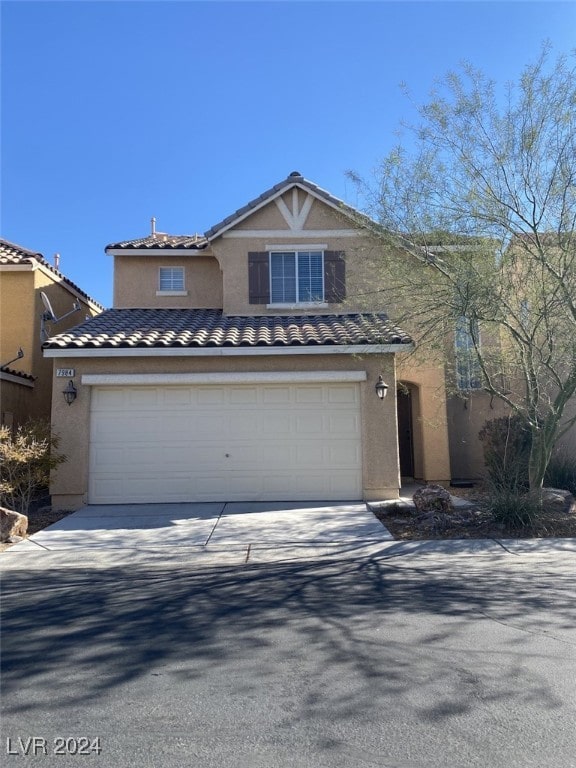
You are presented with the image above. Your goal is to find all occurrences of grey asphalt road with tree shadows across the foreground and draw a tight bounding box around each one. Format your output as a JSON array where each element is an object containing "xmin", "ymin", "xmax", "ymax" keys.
[{"xmin": 0, "ymin": 553, "xmax": 576, "ymax": 768}]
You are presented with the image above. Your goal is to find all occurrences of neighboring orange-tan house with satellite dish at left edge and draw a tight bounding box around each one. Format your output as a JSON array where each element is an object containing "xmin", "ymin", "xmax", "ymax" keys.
[{"xmin": 0, "ymin": 240, "xmax": 103, "ymax": 427}]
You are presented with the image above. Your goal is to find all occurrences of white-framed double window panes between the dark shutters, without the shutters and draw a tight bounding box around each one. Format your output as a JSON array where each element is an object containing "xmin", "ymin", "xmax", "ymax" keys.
[{"xmin": 270, "ymin": 251, "xmax": 324, "ymax": 304}]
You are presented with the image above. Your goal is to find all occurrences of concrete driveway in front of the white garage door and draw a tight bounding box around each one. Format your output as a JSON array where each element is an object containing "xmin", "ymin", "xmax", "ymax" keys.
[{"xmin": 2, "ymin": 502, "xmax": 392, "ymax": 566}]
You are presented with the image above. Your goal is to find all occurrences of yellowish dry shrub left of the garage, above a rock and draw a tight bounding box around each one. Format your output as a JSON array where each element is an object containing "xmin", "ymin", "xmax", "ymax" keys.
[{"xmin": 0, "ymin": 421, "xmax": 66, "ymax": 514}]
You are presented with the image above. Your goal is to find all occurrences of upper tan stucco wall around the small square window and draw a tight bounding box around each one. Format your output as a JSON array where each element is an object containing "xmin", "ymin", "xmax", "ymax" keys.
[{"xmin": 114, "ymin": 255, "xmax": 222, "ymax": 309}]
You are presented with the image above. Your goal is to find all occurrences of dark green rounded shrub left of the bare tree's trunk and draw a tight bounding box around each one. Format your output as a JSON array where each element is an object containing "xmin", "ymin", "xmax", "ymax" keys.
[{"xmin": 478, "ymin": 416, "xmax": 532, "ymax": 494}]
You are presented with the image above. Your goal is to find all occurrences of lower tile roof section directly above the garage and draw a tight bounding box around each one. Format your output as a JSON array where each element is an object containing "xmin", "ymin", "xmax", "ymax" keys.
[{"xmin": 43, "ymin": 309, "xmax": 412, "ymax": 350}]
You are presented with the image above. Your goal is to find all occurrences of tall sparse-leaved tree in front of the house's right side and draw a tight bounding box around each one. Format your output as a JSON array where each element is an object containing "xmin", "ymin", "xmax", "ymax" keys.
[{"xmin": 349, "ymin": 47, "xmax": 576, "ymax": 489}]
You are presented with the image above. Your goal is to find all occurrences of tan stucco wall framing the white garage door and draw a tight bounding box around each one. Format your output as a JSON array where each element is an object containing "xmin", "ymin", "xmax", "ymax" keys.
[{"xmin": 51, "ymin": 355, "xmax": 400, "ymax": 508}]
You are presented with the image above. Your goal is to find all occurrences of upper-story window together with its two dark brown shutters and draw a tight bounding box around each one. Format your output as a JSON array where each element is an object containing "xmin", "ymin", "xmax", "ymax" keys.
[{"xmin": 248, "ymin": 245, "xmax": 346, "ymax": 308}]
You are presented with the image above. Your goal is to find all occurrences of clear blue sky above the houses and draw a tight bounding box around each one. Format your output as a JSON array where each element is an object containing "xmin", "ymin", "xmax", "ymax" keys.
[{"xmin": 0, "ymin": 0, "xmax": 576, "ymax": 306}]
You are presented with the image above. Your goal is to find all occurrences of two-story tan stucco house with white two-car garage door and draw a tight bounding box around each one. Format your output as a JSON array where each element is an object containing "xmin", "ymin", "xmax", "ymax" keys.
[{"xmin": 44, "ymin": 172, "xmax": 450, "ymax": 509}]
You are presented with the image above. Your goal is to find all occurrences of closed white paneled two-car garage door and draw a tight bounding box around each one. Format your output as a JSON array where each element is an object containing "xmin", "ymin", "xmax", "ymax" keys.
[{"xmin": 89, "ymin": 383, "xmax": 362, "ymax": 504}]
